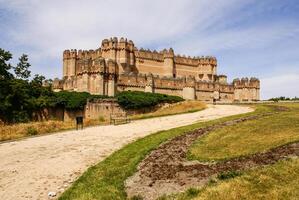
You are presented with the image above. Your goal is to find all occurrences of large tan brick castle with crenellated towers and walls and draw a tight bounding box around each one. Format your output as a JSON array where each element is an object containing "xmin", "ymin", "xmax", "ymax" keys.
[{"xmin": 53, "ymin": 38, "xmax": 260, "ymax": 103}]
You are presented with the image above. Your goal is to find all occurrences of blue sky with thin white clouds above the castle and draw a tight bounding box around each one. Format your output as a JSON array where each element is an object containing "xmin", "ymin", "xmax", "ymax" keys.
[{"xmin": 0, "ymin": 0, "xmax": 299, "ymax": 99}]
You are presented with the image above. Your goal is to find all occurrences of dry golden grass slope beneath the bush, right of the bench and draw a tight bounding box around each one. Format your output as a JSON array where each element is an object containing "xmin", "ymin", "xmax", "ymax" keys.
[{"xmin": 130, "ymin": 101, "xmax": 206, "ymax": 119}]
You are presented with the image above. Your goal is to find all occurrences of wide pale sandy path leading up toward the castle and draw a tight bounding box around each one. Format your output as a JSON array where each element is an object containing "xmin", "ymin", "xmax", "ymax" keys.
[{"xmin": 0, "ymin": 105, "xmax": 252, "ymax": 200}]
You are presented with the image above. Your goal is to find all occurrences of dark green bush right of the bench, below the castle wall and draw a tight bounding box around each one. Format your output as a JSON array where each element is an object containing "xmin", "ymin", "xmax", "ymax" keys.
[{"xmin": 116, "ymin": 91, "xmax": 184, "ymax": 110}]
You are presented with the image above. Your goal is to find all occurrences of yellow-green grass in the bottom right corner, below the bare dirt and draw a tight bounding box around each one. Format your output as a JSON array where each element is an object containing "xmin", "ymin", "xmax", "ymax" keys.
[{"xmin": 163, "ymin": 158, "xmax": 299, "ymax": 200}]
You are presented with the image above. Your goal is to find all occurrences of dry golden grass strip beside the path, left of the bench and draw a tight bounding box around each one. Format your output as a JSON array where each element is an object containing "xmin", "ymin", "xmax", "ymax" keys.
[{"xmin": 0, "ymin": 120, "xmax": 108, "ymax": 141}]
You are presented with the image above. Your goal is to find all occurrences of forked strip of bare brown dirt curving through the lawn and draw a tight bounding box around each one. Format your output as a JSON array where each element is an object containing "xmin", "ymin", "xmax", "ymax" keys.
[{"xmin": 126, "ymin": 113, "xmax": 299, "ymax": 200}]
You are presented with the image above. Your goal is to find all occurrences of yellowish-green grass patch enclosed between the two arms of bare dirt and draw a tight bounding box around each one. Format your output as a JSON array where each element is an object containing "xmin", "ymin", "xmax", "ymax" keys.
[{"xmin": 188, "ymin": 103, "xmax": 299, "ymax": 161}]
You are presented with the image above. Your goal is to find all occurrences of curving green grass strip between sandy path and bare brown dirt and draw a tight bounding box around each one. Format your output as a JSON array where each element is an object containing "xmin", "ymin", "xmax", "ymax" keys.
[{"xmin": 59, "ymin": 106, "xmax": 264, "ymax": 200}]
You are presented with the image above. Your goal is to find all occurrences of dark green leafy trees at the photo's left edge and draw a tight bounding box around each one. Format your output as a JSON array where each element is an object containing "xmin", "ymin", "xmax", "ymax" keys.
[{"xmin": 0, "ymin": 49, "xmax": 55, "ymax": 123}]
